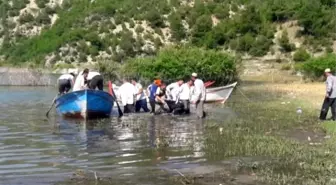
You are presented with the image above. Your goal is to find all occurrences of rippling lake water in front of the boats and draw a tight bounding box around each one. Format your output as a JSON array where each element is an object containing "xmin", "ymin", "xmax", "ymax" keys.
[{"xmin": 0, "ymin": 87, "xmax": 236, "ymax": 185}]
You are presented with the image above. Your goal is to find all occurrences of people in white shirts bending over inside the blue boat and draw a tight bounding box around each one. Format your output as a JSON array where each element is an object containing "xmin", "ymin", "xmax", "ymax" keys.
[{"xmin": 58, "ymin": 69, "xmax": 104, "ymax": 95}]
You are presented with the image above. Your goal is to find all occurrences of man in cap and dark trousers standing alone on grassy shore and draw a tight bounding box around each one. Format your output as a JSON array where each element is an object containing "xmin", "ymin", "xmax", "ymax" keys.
[{"xmin": 320, "ymin": 68, "xmax": 336, "ymax": 120}]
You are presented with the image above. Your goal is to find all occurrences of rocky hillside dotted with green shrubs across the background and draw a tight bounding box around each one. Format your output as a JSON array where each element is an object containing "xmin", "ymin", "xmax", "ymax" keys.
[{"xmin": 0, "ymin": 0, "xmax": 336, "ymax": 66}]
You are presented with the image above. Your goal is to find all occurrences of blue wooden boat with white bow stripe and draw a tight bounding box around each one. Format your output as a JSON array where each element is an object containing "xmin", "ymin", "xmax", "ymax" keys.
[{"xmin": 55, "ymin": 90, "xmax": 114, "ymax": 119}]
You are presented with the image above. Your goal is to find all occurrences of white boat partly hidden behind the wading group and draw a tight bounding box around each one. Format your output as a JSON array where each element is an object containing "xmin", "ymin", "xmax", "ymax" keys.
[{"xmin": 205, "ymin": 82, "xmax": 237, "ymax": 103}]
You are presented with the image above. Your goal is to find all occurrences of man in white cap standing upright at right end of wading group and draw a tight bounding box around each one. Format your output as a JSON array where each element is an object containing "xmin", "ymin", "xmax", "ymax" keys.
[{"xmin": 191, "ymin": 73, "xmax": 206, "ymax": 118}]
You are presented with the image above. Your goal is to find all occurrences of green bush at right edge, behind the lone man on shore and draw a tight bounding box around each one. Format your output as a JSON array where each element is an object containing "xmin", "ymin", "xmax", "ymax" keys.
[{"xmin": 300, "ymin": 54, "xmax": 336, "ymax": 78}]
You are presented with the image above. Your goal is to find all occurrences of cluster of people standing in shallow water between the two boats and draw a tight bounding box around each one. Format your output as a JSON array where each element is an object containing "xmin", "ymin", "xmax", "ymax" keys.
[{"xmin": 118, "ymin": 73, "xmax": 206, "ymax": 118}]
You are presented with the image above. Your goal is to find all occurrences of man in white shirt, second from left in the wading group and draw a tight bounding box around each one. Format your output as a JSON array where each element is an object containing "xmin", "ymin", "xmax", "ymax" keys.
[{"xmin": 131, "ymin": 78, "xmax": 149, "ymax": 112}]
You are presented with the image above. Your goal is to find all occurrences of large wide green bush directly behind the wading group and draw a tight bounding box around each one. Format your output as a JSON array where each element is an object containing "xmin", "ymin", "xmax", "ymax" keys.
[{"xmin": 123, "ymin": 47, "xmax": 237, "ymax": 85}]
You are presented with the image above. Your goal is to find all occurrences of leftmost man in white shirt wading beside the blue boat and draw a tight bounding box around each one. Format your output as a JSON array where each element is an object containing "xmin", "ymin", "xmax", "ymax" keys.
[{"xmin": 119, "ymin": 79, "xmax": 136, "ymax": 113}]
